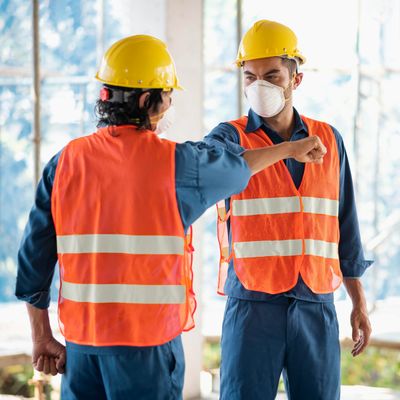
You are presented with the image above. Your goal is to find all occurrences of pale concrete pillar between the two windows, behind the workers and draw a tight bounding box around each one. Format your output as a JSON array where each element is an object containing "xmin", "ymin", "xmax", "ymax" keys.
[{"xmin": 107, "ymin": 0, "xmax": 203, "ymax": 399}]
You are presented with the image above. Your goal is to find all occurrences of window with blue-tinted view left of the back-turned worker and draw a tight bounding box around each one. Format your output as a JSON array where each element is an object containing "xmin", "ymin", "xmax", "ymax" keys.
[{"xmin": 0, "ymin": 0, "xmax": 165, "ymax": 302}]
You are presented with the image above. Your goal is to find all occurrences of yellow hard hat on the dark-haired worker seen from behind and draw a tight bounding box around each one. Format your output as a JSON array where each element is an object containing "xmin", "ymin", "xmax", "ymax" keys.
[{"xmin": 96, "ymin": 35, "xmax": 183, "ymax": 90}]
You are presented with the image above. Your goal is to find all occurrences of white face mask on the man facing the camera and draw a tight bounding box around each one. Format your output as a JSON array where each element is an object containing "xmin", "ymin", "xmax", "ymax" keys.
[{"xmin": 244, "ymin": 80, "xmax": 287, "ymax": 118}]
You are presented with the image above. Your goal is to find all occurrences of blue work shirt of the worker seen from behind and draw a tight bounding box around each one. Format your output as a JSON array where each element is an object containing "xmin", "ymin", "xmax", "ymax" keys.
[{"xmin": 15, "ymin": 134, "xmax": 251, "ymax": 354}]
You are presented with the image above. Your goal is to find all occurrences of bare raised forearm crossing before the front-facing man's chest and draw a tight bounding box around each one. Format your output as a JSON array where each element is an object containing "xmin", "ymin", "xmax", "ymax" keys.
[{"xmin": 242, "ymin": 142, "xmax": 292, "ymax": 175}]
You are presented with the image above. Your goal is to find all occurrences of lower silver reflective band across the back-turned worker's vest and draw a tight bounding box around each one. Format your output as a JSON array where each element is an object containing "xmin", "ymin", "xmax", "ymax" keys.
[{"xmin": 61, "ymin": 282, "xmax": 186, "ymax": 304}]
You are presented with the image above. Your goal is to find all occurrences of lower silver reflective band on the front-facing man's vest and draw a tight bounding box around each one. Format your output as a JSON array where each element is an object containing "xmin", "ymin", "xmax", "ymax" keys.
[{"xmin": 233, "ymin": 239, "xmax": 338, "ymax": 259}]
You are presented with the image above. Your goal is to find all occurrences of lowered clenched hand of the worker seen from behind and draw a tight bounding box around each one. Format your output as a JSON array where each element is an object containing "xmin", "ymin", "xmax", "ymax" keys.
[{"xmin": 32, "ymin": 336, "xmax": 66, "ymax": 375}]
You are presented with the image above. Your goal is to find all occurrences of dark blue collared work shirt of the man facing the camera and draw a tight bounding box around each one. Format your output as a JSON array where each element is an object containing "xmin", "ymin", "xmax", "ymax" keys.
[{"xmin": 204, "ymin": 109, "xmax": 372, "ymax": 302}]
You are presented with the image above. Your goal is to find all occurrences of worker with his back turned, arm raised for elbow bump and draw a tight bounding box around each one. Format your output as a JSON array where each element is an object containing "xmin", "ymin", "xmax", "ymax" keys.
[{"xmin": 16, "ymin": 35, "xmax": 326, "ymax": 400}]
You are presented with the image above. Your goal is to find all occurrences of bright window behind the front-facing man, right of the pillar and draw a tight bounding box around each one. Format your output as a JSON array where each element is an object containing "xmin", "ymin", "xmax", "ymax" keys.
[{"xmin": 203, "ymin": 0, "xmax": 400, "ymax": 335}]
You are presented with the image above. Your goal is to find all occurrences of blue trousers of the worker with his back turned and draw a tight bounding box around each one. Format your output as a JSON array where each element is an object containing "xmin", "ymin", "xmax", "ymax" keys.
[{"xmin": 61, "ymin": 336, "xmax": 185, "ymax": 400}]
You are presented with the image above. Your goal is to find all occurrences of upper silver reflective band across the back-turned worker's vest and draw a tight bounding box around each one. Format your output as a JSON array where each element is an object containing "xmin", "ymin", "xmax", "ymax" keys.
[{"xmin": 57, "ymin": 235, "xmax": 184, "ymax": 255}]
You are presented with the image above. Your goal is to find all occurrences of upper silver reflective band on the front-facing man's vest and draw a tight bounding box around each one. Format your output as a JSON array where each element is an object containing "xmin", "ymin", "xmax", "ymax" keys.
[{"xmin": 232, "ymin": 196, "xmax": 339, "ymax": 217}]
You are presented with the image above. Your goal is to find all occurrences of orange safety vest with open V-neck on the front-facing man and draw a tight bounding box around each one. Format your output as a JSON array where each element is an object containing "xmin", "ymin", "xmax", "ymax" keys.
[{"xmin": 217, "ymin": 116, "xmax": 343, "ymax": 294}]
